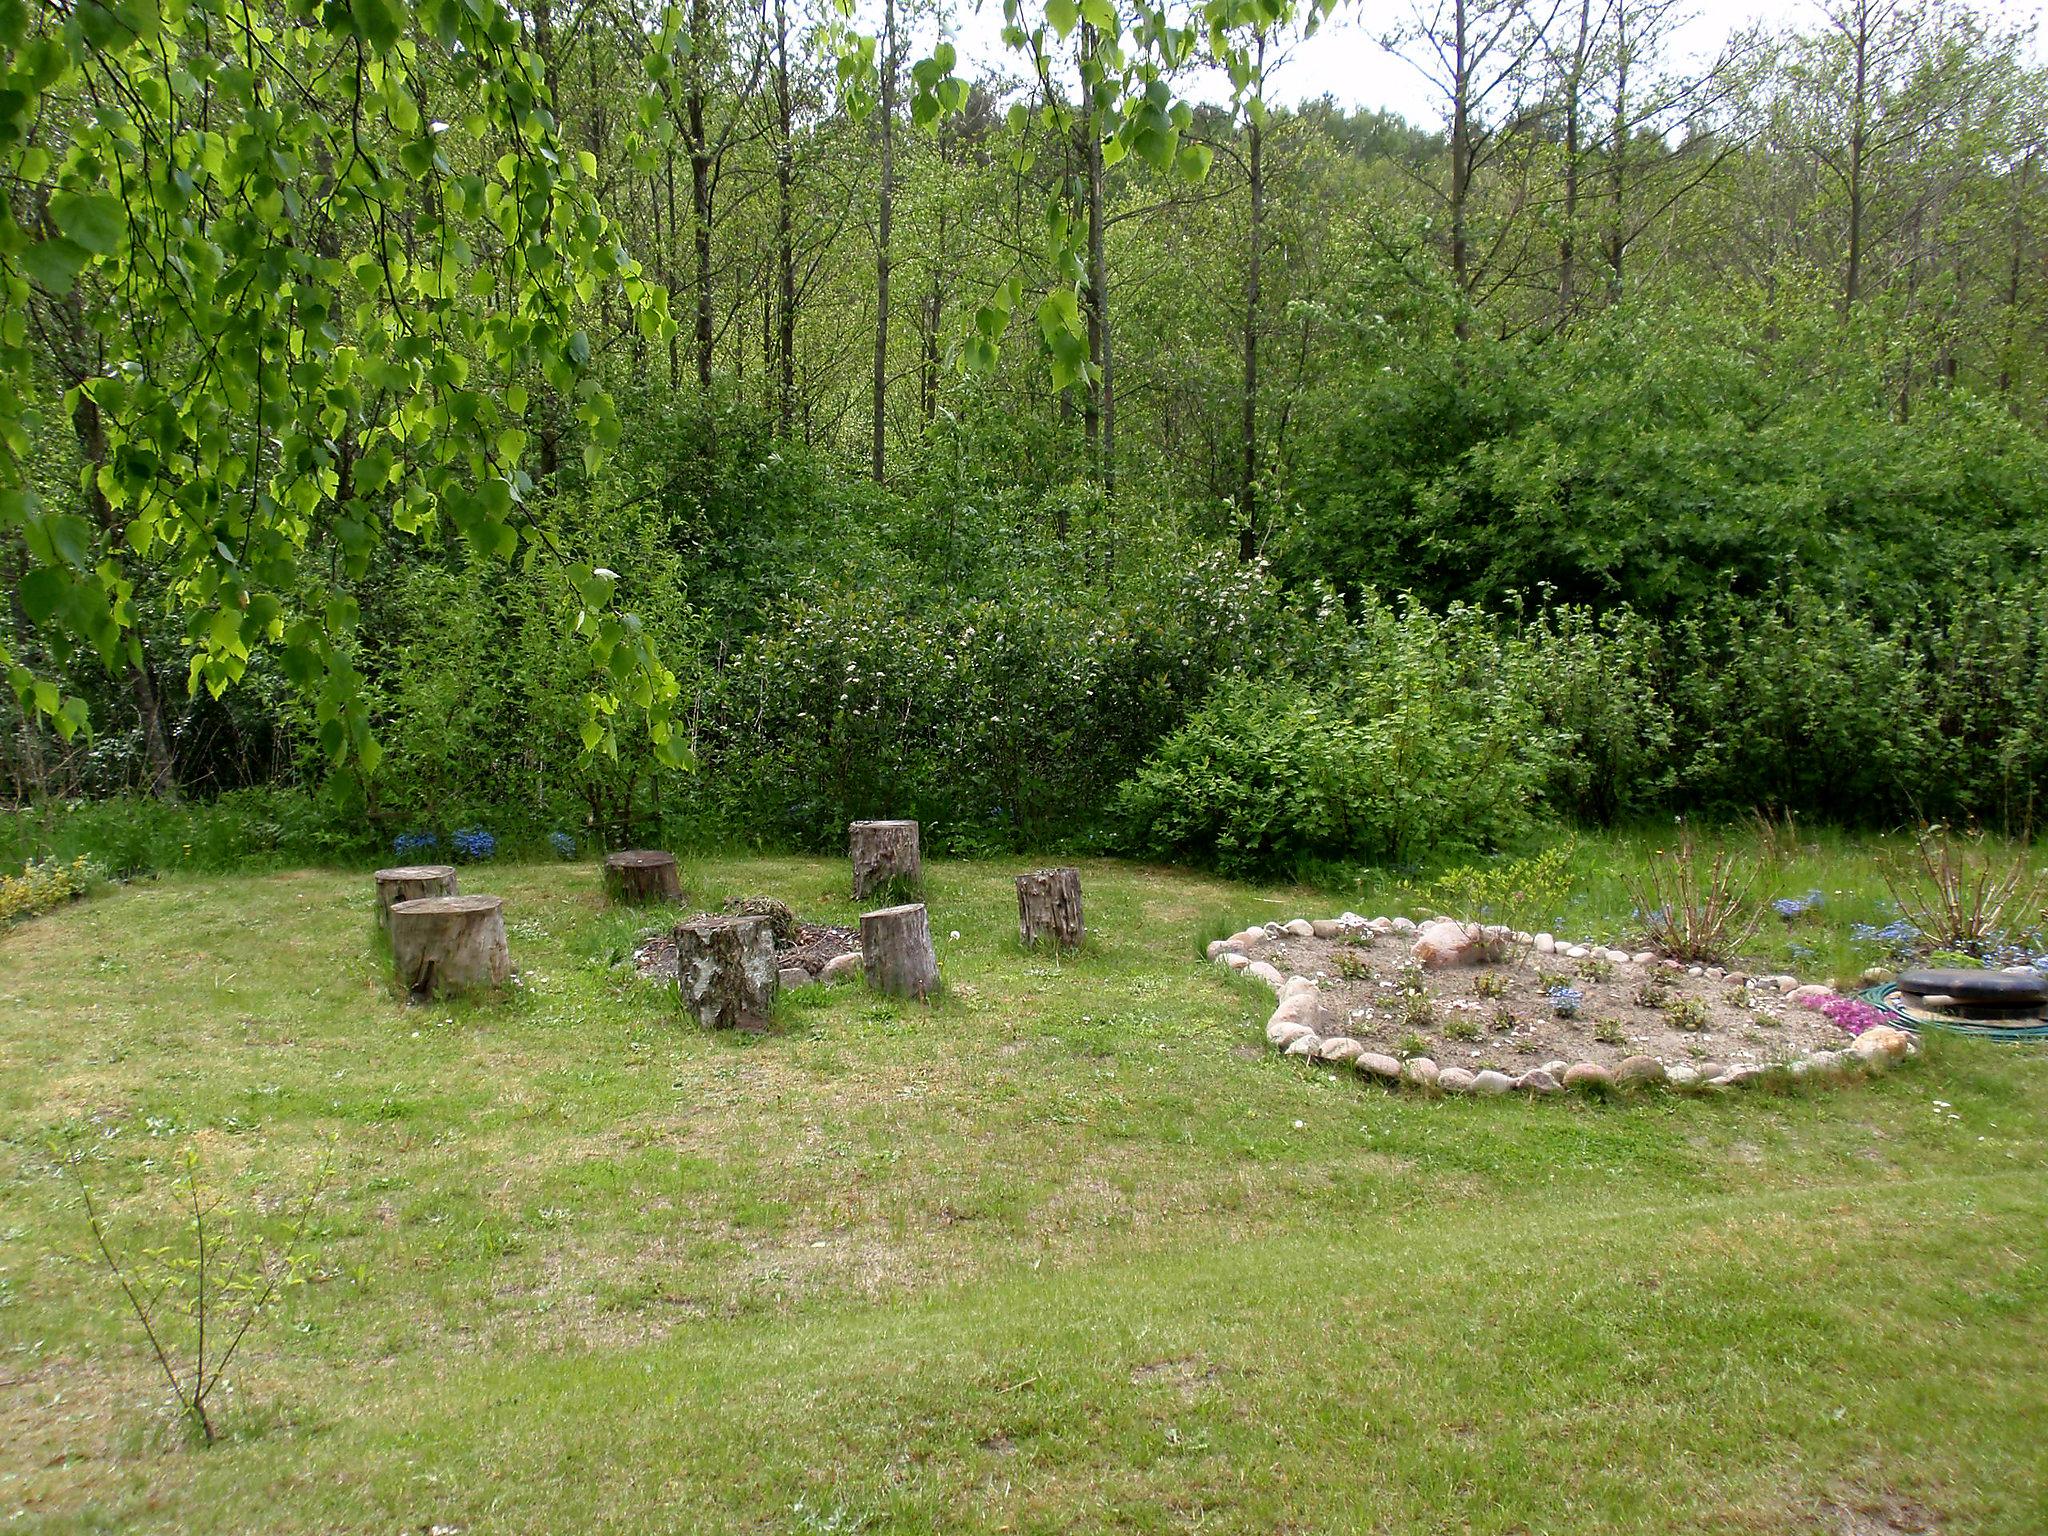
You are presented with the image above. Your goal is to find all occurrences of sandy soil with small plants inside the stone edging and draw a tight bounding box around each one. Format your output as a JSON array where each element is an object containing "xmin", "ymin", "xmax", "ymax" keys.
[{"xmin": 1245, "ymin": 934, "xmax": 1849, "ymax": 1073}]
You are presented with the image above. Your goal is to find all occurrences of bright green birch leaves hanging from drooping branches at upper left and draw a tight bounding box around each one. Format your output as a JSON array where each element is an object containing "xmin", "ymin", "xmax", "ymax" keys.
[{"xmin": 0, "ymin": 0, "xmax": 674, "ymax": 772}]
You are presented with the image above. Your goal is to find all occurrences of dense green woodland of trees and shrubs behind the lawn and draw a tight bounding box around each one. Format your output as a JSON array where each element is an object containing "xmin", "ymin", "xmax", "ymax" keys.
[{"xmin": 0, "ymin": 0, "xmax": 2048, "ymax": 874}]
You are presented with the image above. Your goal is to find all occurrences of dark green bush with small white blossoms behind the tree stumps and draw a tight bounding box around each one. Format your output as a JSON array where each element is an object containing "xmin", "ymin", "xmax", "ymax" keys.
[{"xmin": 688, "ymin": 557, "xmax": 1303, "ymax": 850}]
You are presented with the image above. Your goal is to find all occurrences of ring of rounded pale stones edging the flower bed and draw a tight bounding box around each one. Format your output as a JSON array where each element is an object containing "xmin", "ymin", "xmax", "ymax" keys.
[{"xmin": 1206, "ymin": 911, "xmax": 1919, "ymax": 1096}]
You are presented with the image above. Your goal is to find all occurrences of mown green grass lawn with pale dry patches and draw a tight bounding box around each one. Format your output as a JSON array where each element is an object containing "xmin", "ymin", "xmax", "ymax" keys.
[{"xmin": 0, "ymin": 850, "xmax": 2048, "ymax": 1536}]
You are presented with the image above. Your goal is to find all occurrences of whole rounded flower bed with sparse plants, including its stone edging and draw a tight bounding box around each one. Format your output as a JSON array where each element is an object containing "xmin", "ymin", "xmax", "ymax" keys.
[{"xmin": 1208, "ymin": 913, "xmax": 1919, "ymax": 1094}]
